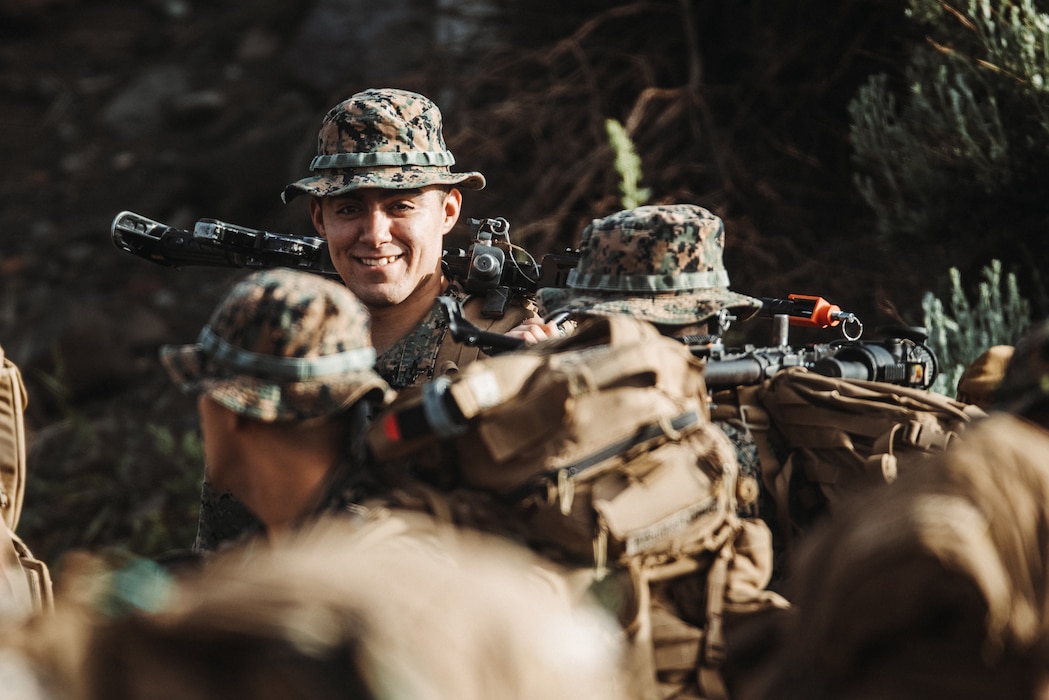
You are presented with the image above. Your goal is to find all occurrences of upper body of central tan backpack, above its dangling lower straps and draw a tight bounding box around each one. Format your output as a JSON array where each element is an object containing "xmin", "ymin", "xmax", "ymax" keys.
[{"xmin": 369, "ymin": 318, "xmax": 736, "ymax": 566}]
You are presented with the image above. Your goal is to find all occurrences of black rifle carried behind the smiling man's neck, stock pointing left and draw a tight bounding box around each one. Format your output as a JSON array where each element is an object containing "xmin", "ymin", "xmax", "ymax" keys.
[{"xmin": 111, "ymin": 211, "xmax": 578, "ymax": 318}]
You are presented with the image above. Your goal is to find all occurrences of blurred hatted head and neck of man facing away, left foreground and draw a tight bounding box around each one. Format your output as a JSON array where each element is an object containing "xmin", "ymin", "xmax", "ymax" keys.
[{"xmin": 160, "ymin": 265, "xmax": 390, "ymax": 538}]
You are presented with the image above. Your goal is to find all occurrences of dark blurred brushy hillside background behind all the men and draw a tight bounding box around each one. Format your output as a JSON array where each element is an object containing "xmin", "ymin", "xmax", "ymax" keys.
[{"xmin": 0, "ymin": 0, "xmax": 1049, "ymax": 560}]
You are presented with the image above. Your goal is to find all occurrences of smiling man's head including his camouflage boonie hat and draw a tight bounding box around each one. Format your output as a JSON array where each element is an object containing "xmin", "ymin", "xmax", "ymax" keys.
[{"xmin": 282, "ymin": 88, "xmax": 485, "ymax": 310}]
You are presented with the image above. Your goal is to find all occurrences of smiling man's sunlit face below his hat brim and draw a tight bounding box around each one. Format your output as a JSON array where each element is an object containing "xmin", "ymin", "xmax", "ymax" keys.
[{"xmin": 309, "ymin": 186, "xmax": 463, "ymax": 309}]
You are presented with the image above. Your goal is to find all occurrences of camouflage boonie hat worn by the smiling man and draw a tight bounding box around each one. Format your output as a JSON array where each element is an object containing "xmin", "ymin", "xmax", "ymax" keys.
[{"xmin": 281, "ymin": 88, "xmax": 485, "ymax": 201}]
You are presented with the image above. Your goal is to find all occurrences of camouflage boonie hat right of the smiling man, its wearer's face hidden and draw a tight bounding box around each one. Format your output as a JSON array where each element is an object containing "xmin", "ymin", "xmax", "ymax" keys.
[{"xmin": 537, "ymin": 205, "xmax": 762, "ymax": 325}]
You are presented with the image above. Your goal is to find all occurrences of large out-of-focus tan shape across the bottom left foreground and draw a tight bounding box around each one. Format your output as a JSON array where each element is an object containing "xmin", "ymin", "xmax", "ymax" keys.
[{"xmin": 0, "ymin": 513, "xmax": 626, "ymax": 700}]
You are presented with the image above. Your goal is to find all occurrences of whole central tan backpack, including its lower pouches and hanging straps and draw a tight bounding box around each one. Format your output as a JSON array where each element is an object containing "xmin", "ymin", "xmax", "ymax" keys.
[{"xmin": 369, "ymin": 317, "xmax": 786, "ymax": 698}]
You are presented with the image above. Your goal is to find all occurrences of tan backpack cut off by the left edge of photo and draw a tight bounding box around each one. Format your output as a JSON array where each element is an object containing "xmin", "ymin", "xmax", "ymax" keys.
[{"xmin": 0, "ymin": 347, "xmax": 52, "ymax": 614}]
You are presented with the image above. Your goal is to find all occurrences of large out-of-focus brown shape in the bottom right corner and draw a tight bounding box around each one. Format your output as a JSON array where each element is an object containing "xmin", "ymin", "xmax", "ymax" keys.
[{"xmin": 748, "ymin": 411, "xmax": 1049, "ymax": 700}]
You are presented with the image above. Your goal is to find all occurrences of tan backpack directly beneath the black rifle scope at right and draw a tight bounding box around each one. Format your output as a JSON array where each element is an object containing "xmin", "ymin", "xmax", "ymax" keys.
[{"xmin": 738, "ymin": 367, "xmax": 986, "ymax": 548}]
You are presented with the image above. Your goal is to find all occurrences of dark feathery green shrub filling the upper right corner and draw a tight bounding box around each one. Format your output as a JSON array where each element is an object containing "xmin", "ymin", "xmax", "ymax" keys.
[{"xmin": 849, "ymin": 0, "xmax": 1049, "ymax": 249}]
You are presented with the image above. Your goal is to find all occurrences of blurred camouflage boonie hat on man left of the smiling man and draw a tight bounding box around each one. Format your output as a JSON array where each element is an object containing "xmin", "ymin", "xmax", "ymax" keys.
[{"xmin": 160, "ymin": 269, "xmax": 389, "ymax": 422}]
